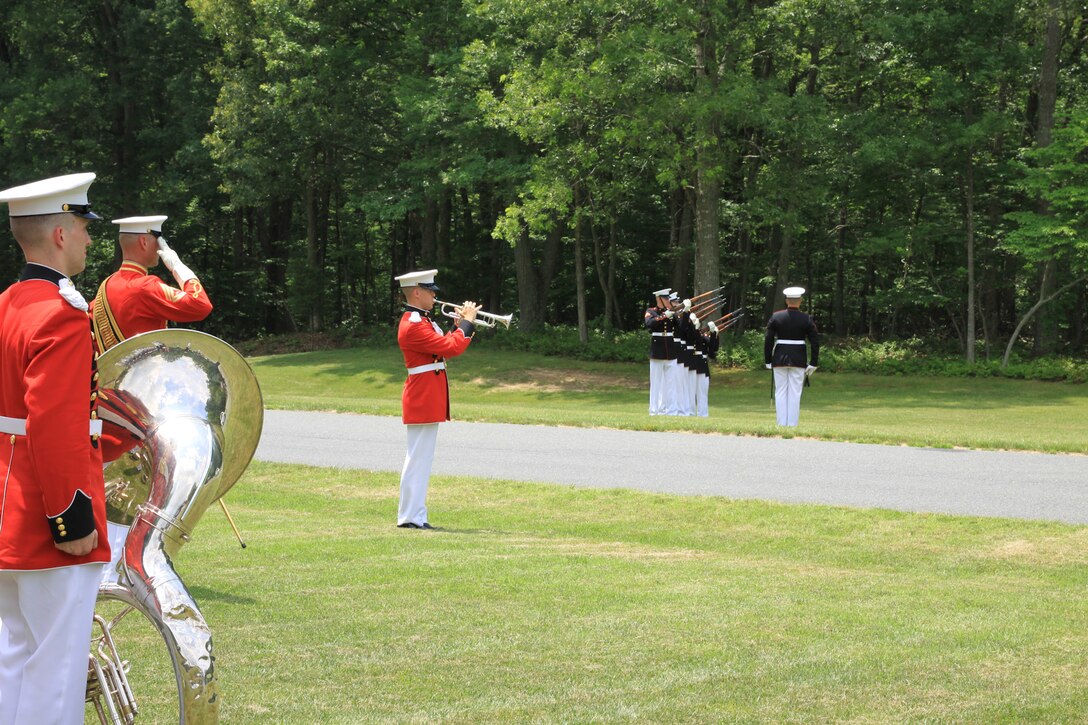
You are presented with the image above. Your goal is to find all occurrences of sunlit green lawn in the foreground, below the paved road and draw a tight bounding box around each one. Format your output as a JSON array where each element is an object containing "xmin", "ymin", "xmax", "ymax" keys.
[{"xmin": 91, "ymin": 463, "xmax": 1088, "ymax": 724}]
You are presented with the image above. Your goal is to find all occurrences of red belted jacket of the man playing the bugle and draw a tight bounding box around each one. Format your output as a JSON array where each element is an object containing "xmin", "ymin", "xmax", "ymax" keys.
[{"xmin": 397, "ymin": 307, "xmax": 473, "ymax": 426}]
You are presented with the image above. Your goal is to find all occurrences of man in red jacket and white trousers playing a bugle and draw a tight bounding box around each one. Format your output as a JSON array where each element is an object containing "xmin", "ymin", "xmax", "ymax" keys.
[{"xmin": 394, "ymin": 269, "xmax": 479, "ymax": 529}]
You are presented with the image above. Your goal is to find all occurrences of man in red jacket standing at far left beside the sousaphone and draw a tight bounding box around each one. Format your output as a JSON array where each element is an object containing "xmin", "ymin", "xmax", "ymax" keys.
[{"xmin": 0, "ymin": 173, "xmax": 110, "ymax": 724}]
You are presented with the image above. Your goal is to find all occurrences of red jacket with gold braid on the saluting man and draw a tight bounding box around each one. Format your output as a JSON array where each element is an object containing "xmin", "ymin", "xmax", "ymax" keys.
[{"xmin": 90, "ymin": 261, "xmax": 211, "ymax": 354}]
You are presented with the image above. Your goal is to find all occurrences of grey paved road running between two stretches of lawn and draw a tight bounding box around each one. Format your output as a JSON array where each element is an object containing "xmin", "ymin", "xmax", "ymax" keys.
[{"xmin": 256, "ymin": 410, "xmax": 1088, "ymax": 524}]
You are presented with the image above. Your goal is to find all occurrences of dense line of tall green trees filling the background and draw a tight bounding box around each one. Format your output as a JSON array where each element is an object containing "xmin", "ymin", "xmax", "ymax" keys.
[{"xmin": 0, "ymin": 0, "xmax": 1088, "ymax": 361}]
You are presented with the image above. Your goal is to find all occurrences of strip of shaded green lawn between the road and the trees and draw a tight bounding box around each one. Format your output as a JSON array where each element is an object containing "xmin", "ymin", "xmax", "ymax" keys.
[{"xmin": 251, "ymin": 341, "xmax": 1088, "ymax": 453}]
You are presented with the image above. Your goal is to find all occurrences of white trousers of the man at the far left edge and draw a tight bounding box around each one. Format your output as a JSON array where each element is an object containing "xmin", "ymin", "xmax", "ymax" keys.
[{"xmin": 0, "ymin": 564, "xmax": 102, "ymax": 725}]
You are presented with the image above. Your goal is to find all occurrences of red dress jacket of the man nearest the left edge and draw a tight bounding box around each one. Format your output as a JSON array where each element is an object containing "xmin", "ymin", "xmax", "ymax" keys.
[{"xmin": 0, "ymin": 265, "xmax": 110, "ymax": 570}]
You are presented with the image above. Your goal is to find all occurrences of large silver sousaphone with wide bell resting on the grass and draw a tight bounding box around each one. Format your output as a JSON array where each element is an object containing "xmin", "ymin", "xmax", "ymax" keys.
[{"xmin": 87, "ymin": 330, "xmax": 264, "ymax": 725}]
